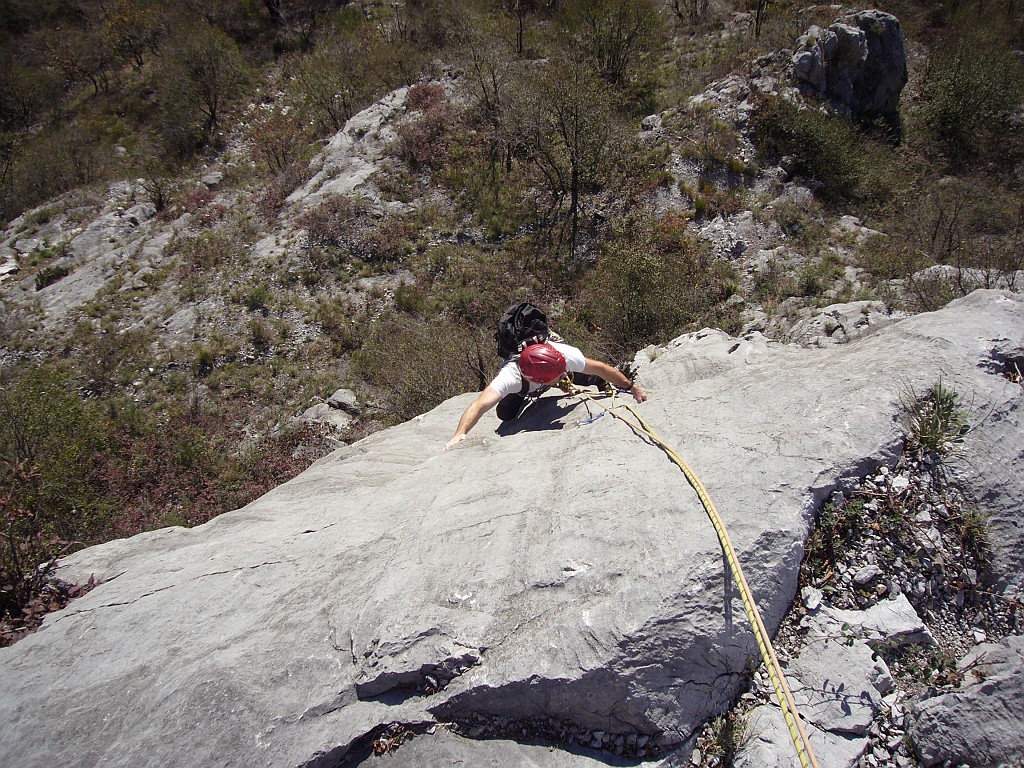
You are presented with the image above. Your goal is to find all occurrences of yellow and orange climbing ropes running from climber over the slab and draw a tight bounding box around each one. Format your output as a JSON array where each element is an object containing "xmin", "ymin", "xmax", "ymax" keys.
[{"xmin": 559, "ymin": 377, "xmax": 818, "ymax": 768}]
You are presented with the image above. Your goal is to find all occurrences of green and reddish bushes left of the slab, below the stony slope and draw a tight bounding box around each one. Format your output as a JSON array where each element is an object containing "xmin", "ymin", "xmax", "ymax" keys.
[{"xmin": 0, "ymin": 366, "xmax": 331, "ymax": 644}]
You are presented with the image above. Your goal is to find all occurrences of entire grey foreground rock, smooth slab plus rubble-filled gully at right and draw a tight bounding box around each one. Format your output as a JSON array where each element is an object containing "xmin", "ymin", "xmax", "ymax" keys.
[{"xmin": 0, "ymin": 292, "xmax": 1024, "ymax": 766}]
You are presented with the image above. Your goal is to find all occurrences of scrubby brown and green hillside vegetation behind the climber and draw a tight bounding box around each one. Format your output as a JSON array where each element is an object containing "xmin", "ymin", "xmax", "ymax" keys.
[{"xmin": 0, "ymin": 0, "xmax": 1024, "ymax": 638}]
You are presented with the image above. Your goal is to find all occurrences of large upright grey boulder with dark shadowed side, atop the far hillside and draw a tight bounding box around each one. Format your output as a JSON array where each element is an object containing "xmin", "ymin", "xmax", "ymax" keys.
[{"xmin": 793, "ymin": 10, "xmax": 907, "ymax": 119}]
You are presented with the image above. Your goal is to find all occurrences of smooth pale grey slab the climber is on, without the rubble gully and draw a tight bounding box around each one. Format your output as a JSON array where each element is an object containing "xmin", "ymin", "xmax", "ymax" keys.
[{"xmin": 0, "ymin": 291, "xmax": 1024, "ymax": 766}]
